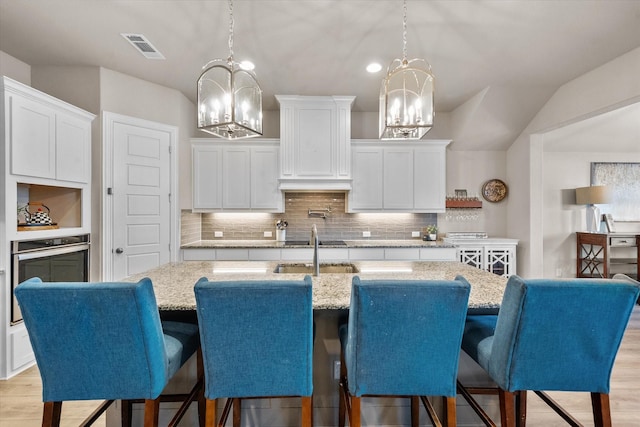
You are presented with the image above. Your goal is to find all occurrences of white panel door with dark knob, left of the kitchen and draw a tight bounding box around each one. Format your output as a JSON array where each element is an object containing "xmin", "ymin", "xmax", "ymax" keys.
[{"xmin": 112, "ymin": 122, "xmax": 171, "ymax": 280}]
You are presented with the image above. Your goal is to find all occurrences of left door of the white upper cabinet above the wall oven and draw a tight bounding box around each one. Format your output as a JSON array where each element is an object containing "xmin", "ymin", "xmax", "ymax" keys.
[{"xmin": 9, "ymin": 95, "xmax": 56, "ymax": 179}]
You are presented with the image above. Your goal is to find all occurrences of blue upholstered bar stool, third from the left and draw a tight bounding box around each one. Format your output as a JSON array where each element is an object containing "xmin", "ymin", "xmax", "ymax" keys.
[{"xmin": 338, "ymin": 276, "xmax": 471, "ymax": 427}]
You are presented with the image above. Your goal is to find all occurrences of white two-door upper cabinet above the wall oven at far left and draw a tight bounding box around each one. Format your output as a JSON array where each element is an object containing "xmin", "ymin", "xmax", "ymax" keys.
[{"xmin": 3, "ymin": 77, "xmax": 95, "ymax": 183}]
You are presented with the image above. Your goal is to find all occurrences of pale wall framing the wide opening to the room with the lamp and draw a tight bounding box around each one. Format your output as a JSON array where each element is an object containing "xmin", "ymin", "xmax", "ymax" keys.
[{"xmin": 507, "ymin": 48, "xmax": 640, "ymax": 277}]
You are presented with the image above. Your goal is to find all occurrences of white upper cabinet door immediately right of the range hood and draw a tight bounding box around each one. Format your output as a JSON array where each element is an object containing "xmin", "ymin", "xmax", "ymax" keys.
[{"xmin": 349, "ymin": 147, "xmax": 383, "ymax": 211}]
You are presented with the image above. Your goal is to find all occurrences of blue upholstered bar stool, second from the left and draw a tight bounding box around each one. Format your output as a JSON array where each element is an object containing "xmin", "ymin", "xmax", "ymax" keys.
[{"xmin": 195, "ymin": 276, "xmax": 313, "ymax": 427}]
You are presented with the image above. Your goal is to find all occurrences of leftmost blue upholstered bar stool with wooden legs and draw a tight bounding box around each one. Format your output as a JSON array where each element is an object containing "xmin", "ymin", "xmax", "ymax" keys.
[{"xmin": 15, "ymin": 278, "xmax": 204, "ymax": 426}]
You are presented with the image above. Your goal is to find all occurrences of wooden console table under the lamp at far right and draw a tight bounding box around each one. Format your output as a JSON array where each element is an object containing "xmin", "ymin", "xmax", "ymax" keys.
[{"xmin": 576, "ymin": 233, "xmax": 640, "ymax": 279}]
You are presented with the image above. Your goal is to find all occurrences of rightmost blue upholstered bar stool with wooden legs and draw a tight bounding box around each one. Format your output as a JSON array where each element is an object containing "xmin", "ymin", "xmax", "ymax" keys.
[{"xmin": 460, "ymin": 276, "xmax": 640, "ymax": 426}]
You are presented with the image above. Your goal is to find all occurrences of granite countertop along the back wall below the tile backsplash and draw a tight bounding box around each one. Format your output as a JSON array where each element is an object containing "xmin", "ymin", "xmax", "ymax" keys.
[{"xmin": 180, "ymin": 239, "xmax": 454, "ymax": 249}]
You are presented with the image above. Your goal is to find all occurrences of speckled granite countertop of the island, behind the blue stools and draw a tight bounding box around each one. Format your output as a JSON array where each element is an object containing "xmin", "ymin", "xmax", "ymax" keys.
[{"xmin": 125, "ymin": 261, "xmax": 507, "ymax": 310}]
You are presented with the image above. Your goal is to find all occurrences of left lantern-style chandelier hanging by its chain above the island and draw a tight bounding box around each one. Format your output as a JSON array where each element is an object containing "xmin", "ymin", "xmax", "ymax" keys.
[{"xmin": 198, "ymin": 0, "xmax": 262, "ymax": 139}]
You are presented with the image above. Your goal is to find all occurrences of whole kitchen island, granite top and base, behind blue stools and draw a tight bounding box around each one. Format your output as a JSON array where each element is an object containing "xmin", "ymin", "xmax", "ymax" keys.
[{"xmin": 116, "ymin": 261, "xmax": 507, "ymax": 427}]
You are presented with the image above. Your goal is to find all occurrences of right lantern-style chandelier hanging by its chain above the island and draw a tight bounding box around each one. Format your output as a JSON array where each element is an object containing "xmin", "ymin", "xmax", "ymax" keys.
[{"xmin": 380, "ymin": 0, "xmax": 435, "ymax": 140}]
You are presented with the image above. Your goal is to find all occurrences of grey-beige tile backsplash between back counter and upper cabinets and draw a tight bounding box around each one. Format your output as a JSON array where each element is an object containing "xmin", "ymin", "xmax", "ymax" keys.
[{"xmin": 181, "ymin": 192, "xmax": 437, "ymax": 244}]
